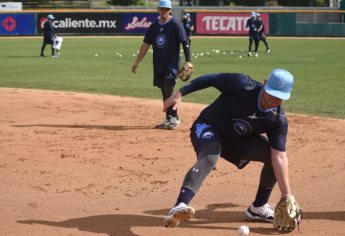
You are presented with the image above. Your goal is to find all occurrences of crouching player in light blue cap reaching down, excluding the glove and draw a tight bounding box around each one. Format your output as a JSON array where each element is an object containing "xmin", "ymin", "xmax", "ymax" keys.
[{"xmin": 164, "ymin": 69, "xmax": 297, "ymax": 227}]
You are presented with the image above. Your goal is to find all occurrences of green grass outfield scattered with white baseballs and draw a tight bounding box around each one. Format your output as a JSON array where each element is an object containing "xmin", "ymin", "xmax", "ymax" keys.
[{"xmin": 0, "ymin": 37, "xmax": 345, "ymax": 119}]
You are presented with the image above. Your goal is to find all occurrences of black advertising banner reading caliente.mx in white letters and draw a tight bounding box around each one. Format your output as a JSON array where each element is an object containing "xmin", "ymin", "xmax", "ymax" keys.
[{"xmin": 37, "ymin": 13, "xmax": 121, "ymax": 34}]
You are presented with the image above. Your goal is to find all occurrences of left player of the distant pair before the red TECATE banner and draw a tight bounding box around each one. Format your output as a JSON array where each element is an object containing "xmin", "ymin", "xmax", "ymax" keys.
[{"xmin": 246, "ymin": 12, "xmax": 261, "ymax": 57}]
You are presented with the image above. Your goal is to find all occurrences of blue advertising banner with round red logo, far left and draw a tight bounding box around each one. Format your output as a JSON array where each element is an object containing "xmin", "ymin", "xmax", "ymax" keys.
[{"xmin": 0, "ymin": 14, "xmax": 35, "ymax": 35}]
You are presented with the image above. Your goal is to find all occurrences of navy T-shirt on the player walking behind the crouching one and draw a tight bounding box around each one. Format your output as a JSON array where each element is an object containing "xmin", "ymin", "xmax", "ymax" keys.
[{"xmin": 144, "ymin": 17, "xmax": 188, "ymax": 74}]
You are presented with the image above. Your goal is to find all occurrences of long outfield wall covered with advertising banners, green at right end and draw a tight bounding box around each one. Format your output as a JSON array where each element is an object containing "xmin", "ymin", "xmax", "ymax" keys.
[{"xmin": 0, "ymin": 9, "xmax": 345, "ymax": 37}]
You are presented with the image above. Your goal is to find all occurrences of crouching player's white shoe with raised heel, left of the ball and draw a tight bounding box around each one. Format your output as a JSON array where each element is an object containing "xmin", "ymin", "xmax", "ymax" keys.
[{"xmin": 164, "ymin": 202, "xmax": 195, "ymax": 227}]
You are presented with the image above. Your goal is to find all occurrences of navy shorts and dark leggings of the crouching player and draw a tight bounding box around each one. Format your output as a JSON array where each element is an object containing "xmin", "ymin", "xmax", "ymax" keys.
[{"xmin": 182, "ymin": 122, "xmax": 277, "ymax": 193}]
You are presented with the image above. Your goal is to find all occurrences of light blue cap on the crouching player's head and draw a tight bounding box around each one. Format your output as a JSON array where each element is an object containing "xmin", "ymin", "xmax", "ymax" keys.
[{"xmin": 265, "ymin": 69, "xmax": 293, "ymax": 100}]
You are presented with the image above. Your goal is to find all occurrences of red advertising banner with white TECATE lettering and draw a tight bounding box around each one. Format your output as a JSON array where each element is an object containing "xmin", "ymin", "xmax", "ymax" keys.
[{"xmin": 196, "ymin": 12, "xmax": 269, "ymax": 35}]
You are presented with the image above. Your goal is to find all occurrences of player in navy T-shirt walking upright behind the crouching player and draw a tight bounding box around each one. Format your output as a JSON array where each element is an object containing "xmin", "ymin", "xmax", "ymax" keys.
[{"xmin": 132, "ymin": 0, "xmax": 190, "ymax": 129}]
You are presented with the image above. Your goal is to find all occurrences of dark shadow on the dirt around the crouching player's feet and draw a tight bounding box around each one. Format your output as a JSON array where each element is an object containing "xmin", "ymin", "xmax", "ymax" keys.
[{"xmin": 17, "ymin": 203, "xmax": 345, "ymax": 236}]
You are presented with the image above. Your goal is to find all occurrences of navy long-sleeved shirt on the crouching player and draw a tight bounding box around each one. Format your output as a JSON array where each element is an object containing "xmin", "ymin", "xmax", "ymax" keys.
[{"xmin": 180, "ymin": 73, "xmax": 288, "ymax": 151}]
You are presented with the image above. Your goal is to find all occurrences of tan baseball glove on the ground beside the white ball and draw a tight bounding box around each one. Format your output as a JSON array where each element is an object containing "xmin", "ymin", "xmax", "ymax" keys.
[{"xmin": 273, "ymin": 195, "xmax": 302, "ymax": 232}]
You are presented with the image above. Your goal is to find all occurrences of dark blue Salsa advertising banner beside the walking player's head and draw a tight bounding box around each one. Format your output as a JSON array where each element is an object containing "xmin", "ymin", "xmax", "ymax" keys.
[{"xmin": 121, "ymin": 13, "xmax": 158, "ymax": 34}]
